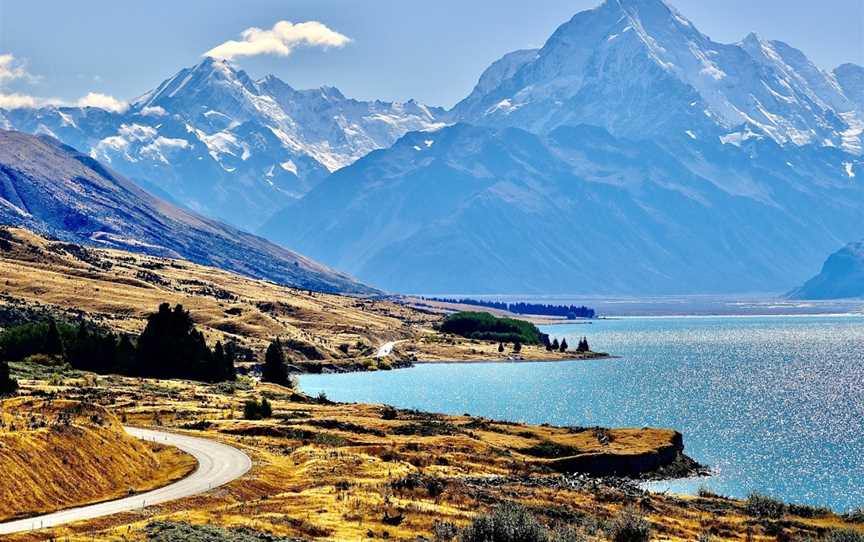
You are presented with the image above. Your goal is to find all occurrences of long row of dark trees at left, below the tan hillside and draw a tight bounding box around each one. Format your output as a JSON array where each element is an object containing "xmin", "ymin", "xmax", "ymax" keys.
[{"xmin": 0, "ymin": 303, "xmax": 237, "ymax": 382}]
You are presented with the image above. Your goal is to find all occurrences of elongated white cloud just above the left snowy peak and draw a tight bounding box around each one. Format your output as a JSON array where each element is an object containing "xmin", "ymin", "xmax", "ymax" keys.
[{"xmin": 204, "ymin": 21, "xmax": 351, "ymax": 60}]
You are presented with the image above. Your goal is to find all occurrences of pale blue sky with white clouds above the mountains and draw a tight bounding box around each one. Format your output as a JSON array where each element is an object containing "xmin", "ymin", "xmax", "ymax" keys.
[{"xmin": 0, "ymin": 0, "xmax": 864, "ymax": 107}]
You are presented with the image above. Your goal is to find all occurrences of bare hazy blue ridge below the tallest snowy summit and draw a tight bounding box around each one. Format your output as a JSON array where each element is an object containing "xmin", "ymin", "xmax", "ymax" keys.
[{"xmin": 263, "ymin": 124, "xmax": 864, "ymax": 294}]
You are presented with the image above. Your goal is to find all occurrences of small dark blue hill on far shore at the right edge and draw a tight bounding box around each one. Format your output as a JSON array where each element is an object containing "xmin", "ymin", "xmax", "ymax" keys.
[{"xmin": 789, "ymin": 242, "xmax": 864, "ymax": 299}]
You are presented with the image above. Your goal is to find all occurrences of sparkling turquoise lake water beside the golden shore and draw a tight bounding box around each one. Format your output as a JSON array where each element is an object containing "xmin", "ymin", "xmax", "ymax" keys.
[{"xmin": 300, "ymin": 316, "xmax": 864, "ymax": 510}]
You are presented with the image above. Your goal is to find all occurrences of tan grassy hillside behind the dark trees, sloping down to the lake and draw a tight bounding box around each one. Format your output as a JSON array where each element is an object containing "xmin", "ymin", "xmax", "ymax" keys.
[{"xmin": 0, "ymin": 228, "xmax": 588, "ymax": 370}]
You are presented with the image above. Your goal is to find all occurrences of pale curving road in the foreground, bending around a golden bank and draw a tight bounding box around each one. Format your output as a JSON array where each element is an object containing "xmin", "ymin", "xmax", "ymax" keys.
[{"xmin": 0, "ymin": 427, "xmax": 252, "ymax": 535}]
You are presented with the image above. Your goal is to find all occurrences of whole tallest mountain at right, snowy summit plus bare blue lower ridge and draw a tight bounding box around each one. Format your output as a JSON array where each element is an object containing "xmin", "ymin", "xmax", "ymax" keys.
[{"xmin": 261, "ymin": 0, "xmax": 864, "ymax": 294}]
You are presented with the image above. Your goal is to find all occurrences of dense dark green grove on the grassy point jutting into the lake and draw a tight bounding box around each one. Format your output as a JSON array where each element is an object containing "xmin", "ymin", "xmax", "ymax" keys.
[{"xmin": 441, "ymin": 312, "xmax": 548, "ymax": 348}]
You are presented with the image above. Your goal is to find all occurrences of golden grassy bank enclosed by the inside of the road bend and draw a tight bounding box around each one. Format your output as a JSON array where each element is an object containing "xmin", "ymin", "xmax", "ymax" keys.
[{"xmin": 0, "ymin": 398, "xmax": 196, "ymax": 521}]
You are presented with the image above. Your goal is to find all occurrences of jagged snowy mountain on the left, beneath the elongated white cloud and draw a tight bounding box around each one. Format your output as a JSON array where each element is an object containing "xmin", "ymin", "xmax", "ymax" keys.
[{"xmin": 0, "ymin": 58, "xmax": 443, "ymax": 229}]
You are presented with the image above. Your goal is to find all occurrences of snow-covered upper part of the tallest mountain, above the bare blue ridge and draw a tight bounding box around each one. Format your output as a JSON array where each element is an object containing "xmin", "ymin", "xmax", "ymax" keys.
[{"xmin": 452, "ymin": 0, "xmax": 864, "ymax": 153}]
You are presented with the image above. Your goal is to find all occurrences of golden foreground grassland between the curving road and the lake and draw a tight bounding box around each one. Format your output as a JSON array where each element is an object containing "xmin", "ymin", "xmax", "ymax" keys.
[{"xmin": 0, "ymin": 377, "xmax": 854, "ymax": 542}]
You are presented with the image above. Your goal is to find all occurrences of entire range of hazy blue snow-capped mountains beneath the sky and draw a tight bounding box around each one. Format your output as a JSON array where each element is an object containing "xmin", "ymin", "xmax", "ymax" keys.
[{"xmin": 0, "ymin": 0, "xmax": 864, "ymax": 294}]
